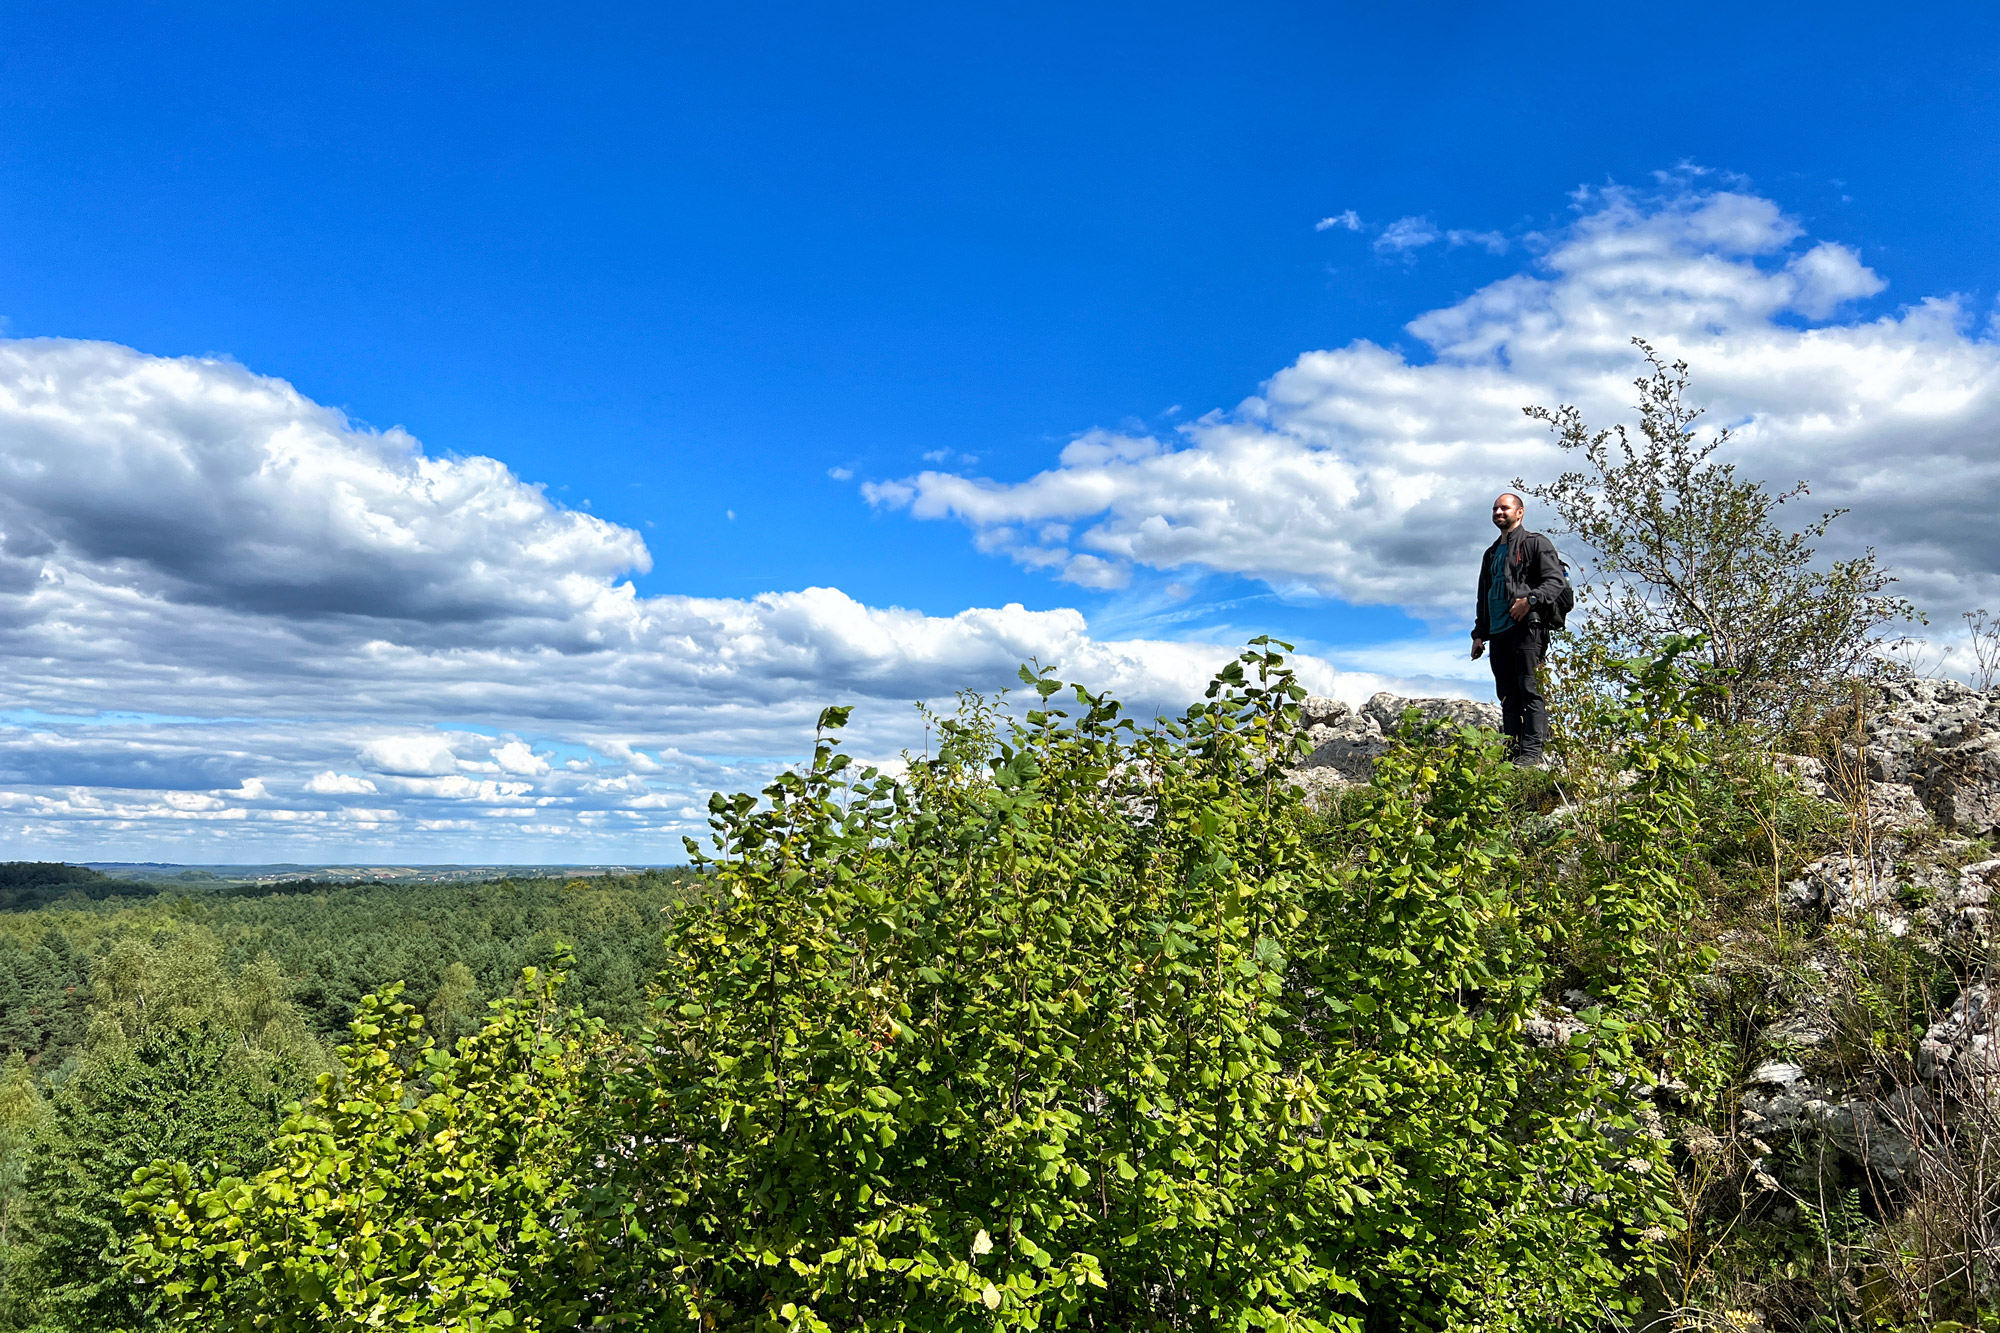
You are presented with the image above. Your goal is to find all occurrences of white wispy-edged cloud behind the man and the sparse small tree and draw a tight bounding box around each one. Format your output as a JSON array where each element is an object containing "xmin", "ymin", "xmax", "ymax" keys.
[{"xmin": 866, "ymin": 179, "xmax": 2000, "ymax": 618}]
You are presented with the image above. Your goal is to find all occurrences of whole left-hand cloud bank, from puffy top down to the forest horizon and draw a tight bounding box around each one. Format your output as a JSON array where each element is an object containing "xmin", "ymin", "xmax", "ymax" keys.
[{"xmin": 0, "ymin": 340, "xmax": 1408, "ymax": 861}]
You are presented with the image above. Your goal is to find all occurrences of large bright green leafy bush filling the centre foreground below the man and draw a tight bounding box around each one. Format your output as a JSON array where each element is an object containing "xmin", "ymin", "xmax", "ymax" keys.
[{"xmin": 488, "ymin": 644, "xmax": 1684, "ymax": 1329}]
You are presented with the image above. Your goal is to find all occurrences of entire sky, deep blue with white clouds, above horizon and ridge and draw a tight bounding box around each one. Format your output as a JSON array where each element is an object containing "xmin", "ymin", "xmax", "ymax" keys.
[{"xmin": 0, "ymin": 4, "xmax": 2000, "ymax": 861}]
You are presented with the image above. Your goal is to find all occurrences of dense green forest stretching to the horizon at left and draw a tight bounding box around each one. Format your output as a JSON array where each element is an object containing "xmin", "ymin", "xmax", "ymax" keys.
[{"xmin": 0, "ymin": 863, "xmax": 694, "ymax": 1329}]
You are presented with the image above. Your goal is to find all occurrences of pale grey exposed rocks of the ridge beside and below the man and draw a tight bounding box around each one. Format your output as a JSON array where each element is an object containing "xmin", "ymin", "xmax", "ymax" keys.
[{"xmin": 1292, "ymin": 681, "xmax": 2000, "ymax": 1189}]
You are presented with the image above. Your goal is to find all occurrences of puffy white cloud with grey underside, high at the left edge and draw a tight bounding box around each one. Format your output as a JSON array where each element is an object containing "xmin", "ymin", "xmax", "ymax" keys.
[{"xmin": 0, "ymin": 338, "xmax": 650, "ymax": 632}]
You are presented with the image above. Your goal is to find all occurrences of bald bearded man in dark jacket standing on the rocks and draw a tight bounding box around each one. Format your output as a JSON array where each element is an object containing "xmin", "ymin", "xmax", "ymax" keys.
[{"xmin": 1472, "ymin": 490, "xmax": 1566, "ymax": 769}]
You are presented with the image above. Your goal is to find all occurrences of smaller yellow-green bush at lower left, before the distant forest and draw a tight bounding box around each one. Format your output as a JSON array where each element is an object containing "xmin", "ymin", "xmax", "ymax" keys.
[{"xmin": 130, "ymin": 969, "xmax": 604, "ymax": 1333}]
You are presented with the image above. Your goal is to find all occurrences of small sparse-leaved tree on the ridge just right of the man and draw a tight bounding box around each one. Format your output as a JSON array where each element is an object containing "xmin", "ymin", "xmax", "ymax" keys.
[{"xmin": 1514, "ymin": 338, "xmax": 1920, "ymax": 727}]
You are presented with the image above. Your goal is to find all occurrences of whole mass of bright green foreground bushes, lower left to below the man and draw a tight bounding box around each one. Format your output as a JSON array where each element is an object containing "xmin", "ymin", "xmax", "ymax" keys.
[{"xmin": 117, "ymin": 640, "xmax": 1700, "ymax": 1333}]
